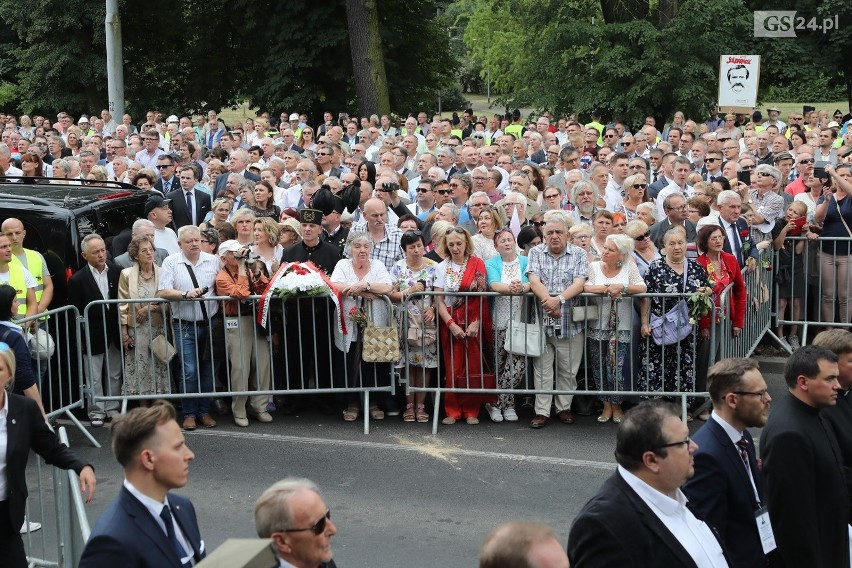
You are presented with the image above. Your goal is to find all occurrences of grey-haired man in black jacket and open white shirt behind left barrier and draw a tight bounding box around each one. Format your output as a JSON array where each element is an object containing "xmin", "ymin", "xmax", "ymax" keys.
[{"xmin": 68, "ymin": 233, "xmax": 124, "ymax": 428}]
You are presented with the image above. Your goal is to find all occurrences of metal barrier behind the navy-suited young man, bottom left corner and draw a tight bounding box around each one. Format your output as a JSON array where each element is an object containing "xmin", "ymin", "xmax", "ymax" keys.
[{"xmin": 23, "ymin": 428, "xmax": 91, "ymax": 568}]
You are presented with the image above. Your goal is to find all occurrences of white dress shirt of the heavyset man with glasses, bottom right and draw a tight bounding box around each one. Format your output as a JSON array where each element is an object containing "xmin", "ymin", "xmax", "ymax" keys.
[{"xmin": 618, "ymin": 466, "xmax": 728, "ymax": 568}]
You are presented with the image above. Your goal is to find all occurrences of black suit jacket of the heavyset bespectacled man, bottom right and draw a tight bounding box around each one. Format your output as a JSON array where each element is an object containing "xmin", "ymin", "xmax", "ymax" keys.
[{"xmin": 568, "ymin": 472, "xmax": 724, "ymax": 568}]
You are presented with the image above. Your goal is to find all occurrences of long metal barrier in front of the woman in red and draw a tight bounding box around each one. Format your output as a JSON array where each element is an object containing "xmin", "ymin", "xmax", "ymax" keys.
[{"xmin": 401, "ymin": 292, "xmax": 716, "ymax": 433}]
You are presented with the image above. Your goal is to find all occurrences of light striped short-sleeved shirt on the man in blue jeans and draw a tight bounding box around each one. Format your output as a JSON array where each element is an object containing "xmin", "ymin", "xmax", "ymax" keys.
[{"xmin": 159, "ymin": 252, "xmax": 220, "ymax": 321}]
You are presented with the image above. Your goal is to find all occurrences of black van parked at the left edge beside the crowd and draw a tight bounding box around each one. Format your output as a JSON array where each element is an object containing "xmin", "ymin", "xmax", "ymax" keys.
[{"xmin": 0, "ymin": 177, "xmax": 151, "ymax": 308}]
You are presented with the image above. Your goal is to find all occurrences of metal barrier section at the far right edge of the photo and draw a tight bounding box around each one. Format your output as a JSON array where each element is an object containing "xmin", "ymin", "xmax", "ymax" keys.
[{"xmin": 772, "ymin": 235, "xmax": 852, "ymax": 351}]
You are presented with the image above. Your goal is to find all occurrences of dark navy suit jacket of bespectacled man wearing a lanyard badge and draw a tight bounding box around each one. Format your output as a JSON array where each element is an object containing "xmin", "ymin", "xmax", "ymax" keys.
[{"xmin": 683, "ymin": 418, "xmax": 766, "ymax": 568}]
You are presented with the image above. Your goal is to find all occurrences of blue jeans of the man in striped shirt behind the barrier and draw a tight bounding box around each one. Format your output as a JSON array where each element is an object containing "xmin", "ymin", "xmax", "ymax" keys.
[{"xmin": 173, "ymin": 320, "xmax": 214, "ymax": 417}]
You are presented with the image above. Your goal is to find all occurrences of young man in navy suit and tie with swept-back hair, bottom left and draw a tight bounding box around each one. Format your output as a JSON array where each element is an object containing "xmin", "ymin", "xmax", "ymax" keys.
[{"xmin": 80, "ymin": 400, "xmax": 206, "ymax": 568}]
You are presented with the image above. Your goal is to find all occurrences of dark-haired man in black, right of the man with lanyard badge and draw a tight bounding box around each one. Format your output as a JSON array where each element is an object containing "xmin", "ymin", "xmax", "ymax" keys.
[{"xmin": 760, "ymin": 345, "xmax": 849, "ymax": 568}]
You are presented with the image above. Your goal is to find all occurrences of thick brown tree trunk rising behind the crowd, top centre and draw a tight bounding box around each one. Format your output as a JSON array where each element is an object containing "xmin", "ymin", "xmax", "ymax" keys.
[{"xmin": 346, "ymin": 0, "xmax": 390, "ymax": 116}]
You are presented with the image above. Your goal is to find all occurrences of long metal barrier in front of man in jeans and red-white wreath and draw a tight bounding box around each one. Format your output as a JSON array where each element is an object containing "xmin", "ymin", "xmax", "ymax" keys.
[{"xmin": 83, "ymin": 296, "xmax": 394, "ymax": 434}]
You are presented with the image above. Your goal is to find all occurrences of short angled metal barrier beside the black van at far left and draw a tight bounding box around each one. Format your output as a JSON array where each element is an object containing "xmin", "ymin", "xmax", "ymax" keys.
[{"xmin": 16, "ymin": 306, "xmax": 101, "ymax": 448}]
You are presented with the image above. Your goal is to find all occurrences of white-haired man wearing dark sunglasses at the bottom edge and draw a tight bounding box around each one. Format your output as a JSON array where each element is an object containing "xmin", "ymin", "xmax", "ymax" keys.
[{"xmin": 254, "ymin": 477, "xmax": 337, "ymax": 568}]
